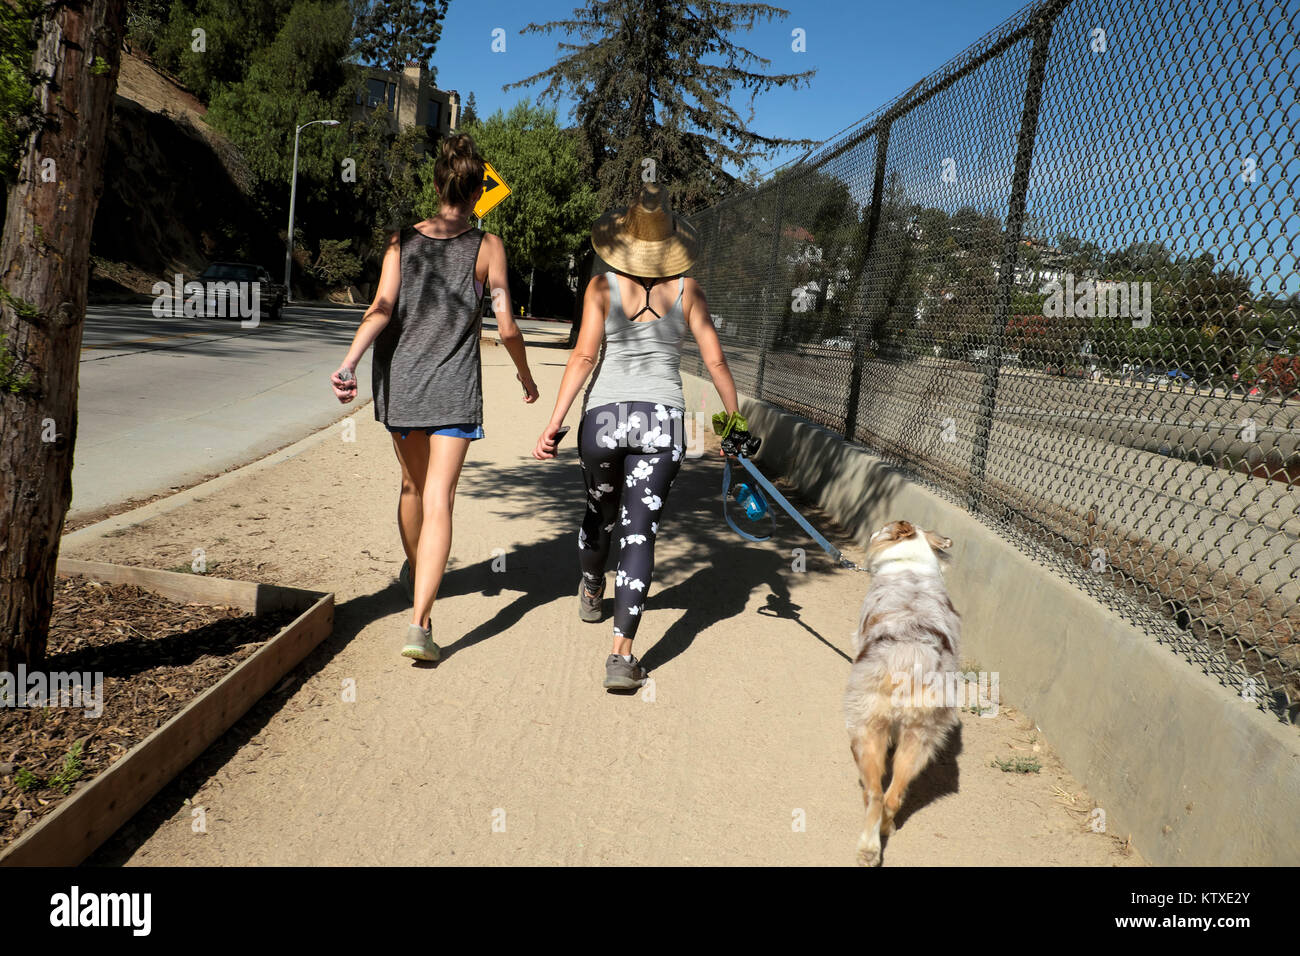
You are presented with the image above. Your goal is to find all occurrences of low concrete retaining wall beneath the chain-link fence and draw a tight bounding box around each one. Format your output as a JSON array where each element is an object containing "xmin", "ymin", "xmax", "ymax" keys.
[{"xmin": 683, "ymin": 375, "xmax": 1300, "ymax": 866}]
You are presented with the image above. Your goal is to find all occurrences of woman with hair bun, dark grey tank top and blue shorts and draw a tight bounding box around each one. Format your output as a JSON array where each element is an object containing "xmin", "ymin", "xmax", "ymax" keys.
[{"xmin": 332, "ymin": 134, "xmax": 537, "ymax": 661}]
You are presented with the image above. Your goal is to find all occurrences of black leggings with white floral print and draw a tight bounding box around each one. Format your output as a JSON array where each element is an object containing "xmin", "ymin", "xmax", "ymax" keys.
[{"xmin": 577, "ymin": 402, "xmax": 685, "ymax": 640}]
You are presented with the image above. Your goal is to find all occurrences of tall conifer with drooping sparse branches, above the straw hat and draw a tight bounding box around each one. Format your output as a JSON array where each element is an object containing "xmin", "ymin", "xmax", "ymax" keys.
[{"xmin": 503, "ymin": 0, "xmax": 815, "ymax": 212}]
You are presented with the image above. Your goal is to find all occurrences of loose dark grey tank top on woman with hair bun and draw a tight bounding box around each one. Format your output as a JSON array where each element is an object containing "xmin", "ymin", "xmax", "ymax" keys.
[{"xmin": 371, "ymin": 226, "xmax": 486, "ymax": 428}]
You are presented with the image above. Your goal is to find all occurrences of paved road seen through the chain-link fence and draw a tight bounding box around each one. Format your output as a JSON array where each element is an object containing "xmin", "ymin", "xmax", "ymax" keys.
[{"xmin": 754, "ymin": 349, "xmax": 1300, "ymax": 630}]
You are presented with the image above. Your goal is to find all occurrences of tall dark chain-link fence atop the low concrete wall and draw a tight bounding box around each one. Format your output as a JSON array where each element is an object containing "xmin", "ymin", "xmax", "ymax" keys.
[{"xmin": 684, "ymin": 0, "xmax": 1300, "ymax": 722}]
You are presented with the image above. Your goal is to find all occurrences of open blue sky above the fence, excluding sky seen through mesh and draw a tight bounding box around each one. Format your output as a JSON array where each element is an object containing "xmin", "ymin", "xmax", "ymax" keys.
[{"xmin": 434, "ymin": 0, "xmax": 1027, "ymax": 169}]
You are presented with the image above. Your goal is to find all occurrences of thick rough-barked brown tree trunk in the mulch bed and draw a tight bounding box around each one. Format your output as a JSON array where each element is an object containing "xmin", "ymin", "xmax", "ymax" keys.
[{"xmin": 0, "ymin": 0, "xmax": 126, "ymax": 672}]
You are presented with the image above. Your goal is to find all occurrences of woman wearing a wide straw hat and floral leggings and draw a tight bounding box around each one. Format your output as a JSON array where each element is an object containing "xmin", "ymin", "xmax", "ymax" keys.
[{"xmin": 533, "ymin": 183, "xmax": 754, "ymax": 691}]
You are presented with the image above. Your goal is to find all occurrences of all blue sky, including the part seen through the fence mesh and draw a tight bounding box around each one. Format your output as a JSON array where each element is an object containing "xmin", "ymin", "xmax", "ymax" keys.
[{"xmin": 423, "ymin": 0, "xmax": 1300, "ymax": 294}]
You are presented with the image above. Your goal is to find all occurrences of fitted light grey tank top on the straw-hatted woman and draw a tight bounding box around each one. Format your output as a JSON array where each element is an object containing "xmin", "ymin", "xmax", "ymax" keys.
[{"xmin": 582, "ymin": 272, "xmax": 686, "ymax": 414}]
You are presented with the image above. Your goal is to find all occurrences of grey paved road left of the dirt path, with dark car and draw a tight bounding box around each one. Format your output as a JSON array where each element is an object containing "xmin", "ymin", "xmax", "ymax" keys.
[{"xmin": 69, "ymin": 303, "xmax": 568, "ymax": 519}]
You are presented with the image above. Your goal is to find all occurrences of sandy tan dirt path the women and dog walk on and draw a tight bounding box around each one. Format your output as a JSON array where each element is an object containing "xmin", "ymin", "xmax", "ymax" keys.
[{"xmin": 65, "ymin": 349, "xmax": 1141, "ymax": 866}]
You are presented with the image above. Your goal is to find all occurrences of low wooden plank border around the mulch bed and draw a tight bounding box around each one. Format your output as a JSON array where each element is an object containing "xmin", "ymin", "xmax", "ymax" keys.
[{"xmin": 0, "ymin": 558, "xmax": 334, "ymax": 866}]
